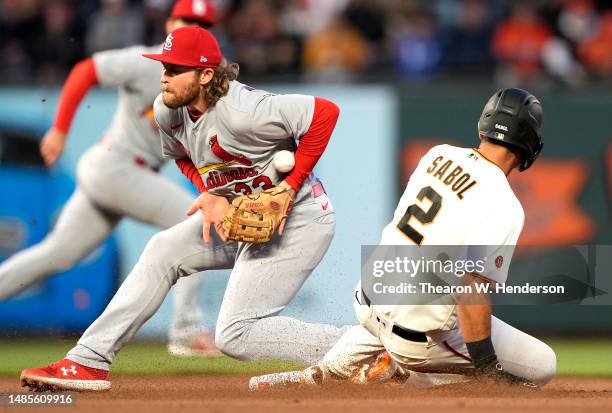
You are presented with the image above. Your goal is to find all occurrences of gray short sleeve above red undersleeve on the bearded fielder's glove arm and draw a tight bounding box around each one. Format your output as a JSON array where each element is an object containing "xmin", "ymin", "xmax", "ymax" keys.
[{"xmin": 251, "ymin": 94, "xmax": 314, "ymax": 141}]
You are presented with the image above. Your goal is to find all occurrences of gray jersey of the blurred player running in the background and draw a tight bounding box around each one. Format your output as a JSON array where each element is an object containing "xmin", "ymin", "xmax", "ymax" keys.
[{"xmin": 93, "ymin": 45, "xmax": 163, "ymax": 168}]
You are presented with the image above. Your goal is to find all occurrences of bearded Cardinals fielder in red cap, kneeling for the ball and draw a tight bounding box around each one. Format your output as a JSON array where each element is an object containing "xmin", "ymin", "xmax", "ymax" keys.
[{"xmin": 21, "ymin": 26, "xmax": 350, "ymax": 390}]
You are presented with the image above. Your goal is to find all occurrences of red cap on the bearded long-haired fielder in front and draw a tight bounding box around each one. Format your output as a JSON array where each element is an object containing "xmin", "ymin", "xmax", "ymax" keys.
[{"xmin": 143, "ymin": 26, "xmax": 222, "ymax": 69}]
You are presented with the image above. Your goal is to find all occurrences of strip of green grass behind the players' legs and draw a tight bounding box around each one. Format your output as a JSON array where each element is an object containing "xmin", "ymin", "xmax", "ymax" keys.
[{"xmin": 0, "ymin": 339, "xmax": 612, "ymax": 377}]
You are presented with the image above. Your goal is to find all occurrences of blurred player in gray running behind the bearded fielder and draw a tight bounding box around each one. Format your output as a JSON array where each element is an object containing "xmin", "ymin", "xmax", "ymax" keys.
[{"xmin": 0, "ymin": 0, "xmax": 220, "ymax": 356}]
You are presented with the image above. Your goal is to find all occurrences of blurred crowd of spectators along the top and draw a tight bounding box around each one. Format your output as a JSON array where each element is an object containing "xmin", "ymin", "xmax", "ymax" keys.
[{"xmin": 0, "ymin": 0, "xmax": 612, "ymax": 88}]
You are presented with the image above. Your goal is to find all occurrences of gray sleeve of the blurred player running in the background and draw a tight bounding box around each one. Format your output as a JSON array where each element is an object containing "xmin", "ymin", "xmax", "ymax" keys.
[{"xmin": 93, "ymin": 46, "xmax": 155, "ymax": 87}]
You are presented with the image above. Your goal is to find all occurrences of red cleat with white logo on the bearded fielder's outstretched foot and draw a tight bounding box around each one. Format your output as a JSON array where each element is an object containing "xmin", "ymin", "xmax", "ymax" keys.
[{"xmin": 19, "ymin": 359, "xmax": 111, "ymax": 391}]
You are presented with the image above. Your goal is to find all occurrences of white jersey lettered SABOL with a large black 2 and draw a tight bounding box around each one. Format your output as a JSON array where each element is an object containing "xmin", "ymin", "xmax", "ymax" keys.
[{"xmin": 376, "ymin": 145, "xmax": 525, "ymax": 331}]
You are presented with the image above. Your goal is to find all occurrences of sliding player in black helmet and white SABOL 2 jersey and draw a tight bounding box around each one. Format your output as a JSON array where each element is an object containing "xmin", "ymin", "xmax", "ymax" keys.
[{"xmin": 251, "ymin": 88, "xmax": 557, "ymax": 390}]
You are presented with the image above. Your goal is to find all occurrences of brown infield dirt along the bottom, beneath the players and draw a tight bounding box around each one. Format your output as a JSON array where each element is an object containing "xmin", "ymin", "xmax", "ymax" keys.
[{"xmin": 0, "ymin": 376, "xmax": 612, "ymax": 413}]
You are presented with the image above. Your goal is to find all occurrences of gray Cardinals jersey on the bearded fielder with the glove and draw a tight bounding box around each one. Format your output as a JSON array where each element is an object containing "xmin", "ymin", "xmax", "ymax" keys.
[{"xmin": 155, "ymin": 81, "xmax": 314, "ymax": 197}]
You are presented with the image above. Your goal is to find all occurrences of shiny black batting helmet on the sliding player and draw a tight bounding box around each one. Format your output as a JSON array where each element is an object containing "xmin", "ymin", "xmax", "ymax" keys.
[{"xmin": 478, "ymin": 88, "xmax": 544, "ymax": 171}]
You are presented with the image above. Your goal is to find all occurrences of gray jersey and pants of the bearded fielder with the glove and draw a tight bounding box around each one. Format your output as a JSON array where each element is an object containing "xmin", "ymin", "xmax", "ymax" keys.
[{"xmin": 68, "ymin": 81, "xmax": 350, "ymax": 369}]
